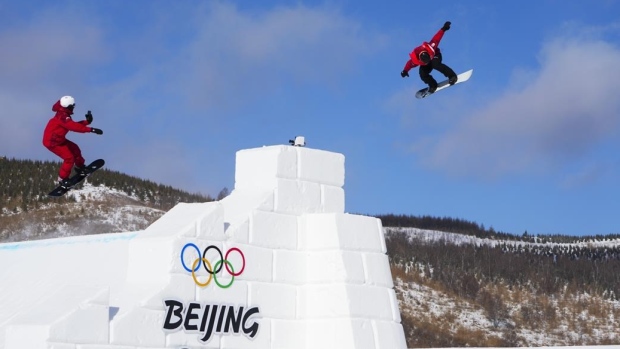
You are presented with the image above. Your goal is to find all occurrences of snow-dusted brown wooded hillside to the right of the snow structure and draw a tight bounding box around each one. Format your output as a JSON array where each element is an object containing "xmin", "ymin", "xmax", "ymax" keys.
[{"xmin": 385, "ymin": 227, "xmax": 620, "ymax": 347}]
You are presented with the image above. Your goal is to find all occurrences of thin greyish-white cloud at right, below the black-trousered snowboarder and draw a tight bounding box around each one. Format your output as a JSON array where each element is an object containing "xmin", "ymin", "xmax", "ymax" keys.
[{"xmin": 413, "ymin": 34, "xmax": 620, "ymax": 177}]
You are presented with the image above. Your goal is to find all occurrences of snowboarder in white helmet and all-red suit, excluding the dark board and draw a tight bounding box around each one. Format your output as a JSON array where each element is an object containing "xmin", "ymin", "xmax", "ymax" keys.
[{"xmin": 43, "ymin": 96, "xmax": 103, "ymax": 185}]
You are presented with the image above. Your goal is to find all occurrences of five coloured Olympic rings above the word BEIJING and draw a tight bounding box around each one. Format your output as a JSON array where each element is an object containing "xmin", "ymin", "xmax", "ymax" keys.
[{"xmin": 181, "ymin": 242, "xmax": 245, "ymax": 288}]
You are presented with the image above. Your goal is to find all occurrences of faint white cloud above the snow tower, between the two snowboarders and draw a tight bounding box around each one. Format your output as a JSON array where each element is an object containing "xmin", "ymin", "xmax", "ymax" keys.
[{"xmin": 167, "ymin": 3, "xmax": 383, "ymax": 108}]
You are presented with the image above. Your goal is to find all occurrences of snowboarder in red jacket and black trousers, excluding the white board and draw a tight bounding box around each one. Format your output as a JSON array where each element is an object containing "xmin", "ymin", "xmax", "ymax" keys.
[{"xmin": 400, "ymin": 22, "xmax": 458, "ymax": 93}]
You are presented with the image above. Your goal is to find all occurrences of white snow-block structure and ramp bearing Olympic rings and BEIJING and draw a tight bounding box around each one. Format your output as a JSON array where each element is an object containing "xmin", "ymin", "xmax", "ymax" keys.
[{"xmin": 0, "ymin": 146, "xmax": 406, "ymax": 349}]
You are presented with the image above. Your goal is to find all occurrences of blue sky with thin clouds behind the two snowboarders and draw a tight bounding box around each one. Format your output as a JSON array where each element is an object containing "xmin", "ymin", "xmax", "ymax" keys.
[{"xmin": 0, "ymin": 0, "xmax": 620, "ymax": 235}]
